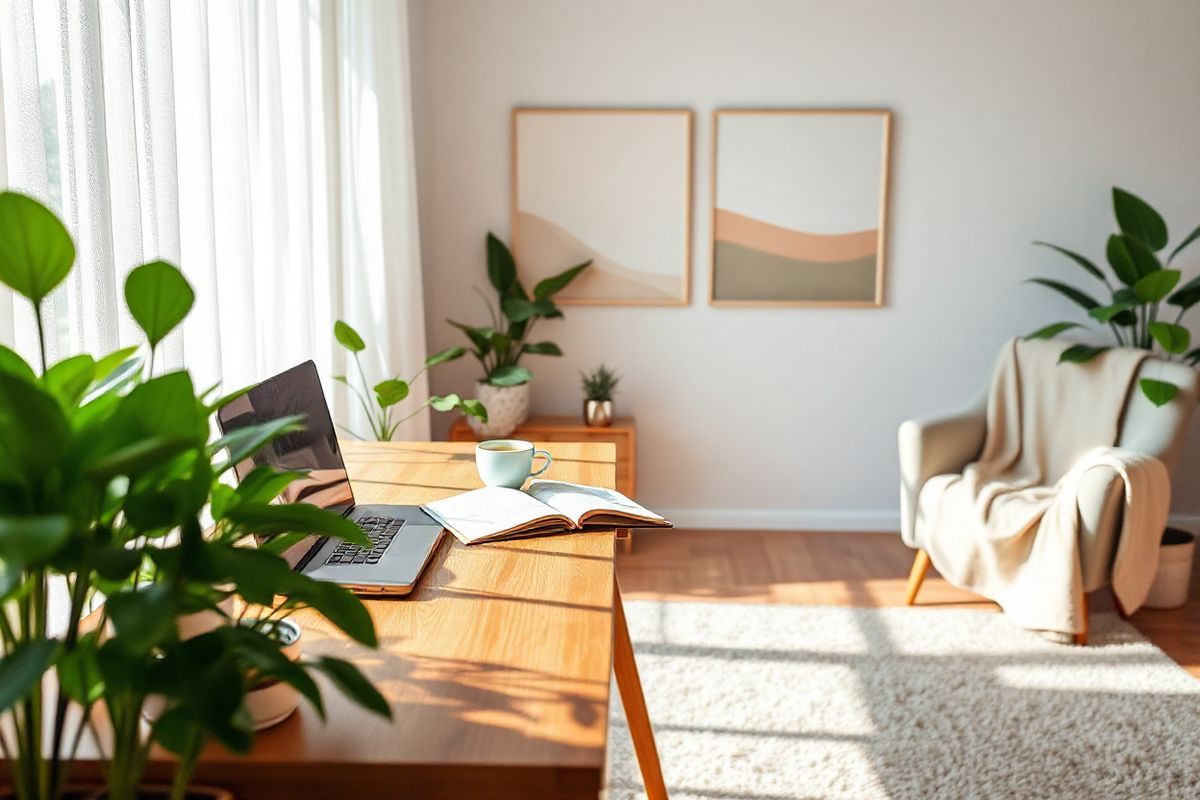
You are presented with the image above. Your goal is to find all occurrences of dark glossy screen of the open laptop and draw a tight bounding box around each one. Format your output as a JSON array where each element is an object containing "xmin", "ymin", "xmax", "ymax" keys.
[{"xmin": 217, "ymin": 361, "xmax": 354, "ymax": 509}]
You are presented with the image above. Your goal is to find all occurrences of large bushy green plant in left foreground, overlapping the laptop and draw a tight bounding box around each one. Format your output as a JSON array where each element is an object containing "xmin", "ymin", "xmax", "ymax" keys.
[{"xmin": 0, "ymin": 192, "xmax": 390, "ymax": 800}]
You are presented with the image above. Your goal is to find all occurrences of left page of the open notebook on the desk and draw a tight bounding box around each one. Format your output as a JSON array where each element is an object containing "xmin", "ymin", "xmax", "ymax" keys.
[{"xmin": 421, "ymin": 486, "xmax": 570, "ymax": 545}]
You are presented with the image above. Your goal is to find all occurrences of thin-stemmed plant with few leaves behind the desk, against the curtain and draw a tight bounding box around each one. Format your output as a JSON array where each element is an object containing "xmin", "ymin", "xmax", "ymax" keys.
[{"xmin": 334, "ymin": 320, "xmax": 487, "ymax": 441}]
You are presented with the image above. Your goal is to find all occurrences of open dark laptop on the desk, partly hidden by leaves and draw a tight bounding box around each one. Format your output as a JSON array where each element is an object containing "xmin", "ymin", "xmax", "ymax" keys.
[{"xmin": 217, "ymin": 361, "xmax": 444, "ymax": 595}]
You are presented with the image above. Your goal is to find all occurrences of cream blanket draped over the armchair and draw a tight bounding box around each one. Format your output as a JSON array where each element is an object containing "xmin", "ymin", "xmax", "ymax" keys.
[{"xmin": 916, "ymin": 339, "xmax": 1171, "ymax": 634}]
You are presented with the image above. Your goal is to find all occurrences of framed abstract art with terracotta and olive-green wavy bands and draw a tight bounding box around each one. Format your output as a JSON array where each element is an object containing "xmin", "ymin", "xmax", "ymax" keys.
[{"xmin": 709, "ymin": 109, "xmax": 892, "ymax": 307}]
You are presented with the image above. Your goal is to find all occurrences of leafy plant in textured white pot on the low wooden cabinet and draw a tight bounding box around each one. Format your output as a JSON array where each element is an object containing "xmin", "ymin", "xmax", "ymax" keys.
[{"xmin": 446, "ymin": 233, "xmax": 592, "ymax": 438}]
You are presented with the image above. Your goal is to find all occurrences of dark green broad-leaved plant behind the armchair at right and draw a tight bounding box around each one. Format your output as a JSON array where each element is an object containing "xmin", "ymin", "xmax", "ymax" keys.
[{"xmin": 1026, "ymin": 186, "xmax": 1200, "ymax": 405}]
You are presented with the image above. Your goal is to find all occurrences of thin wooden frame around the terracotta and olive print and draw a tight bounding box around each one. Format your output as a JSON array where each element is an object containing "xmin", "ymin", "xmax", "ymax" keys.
[{"xmin": 708, "ymin": 108, "xmax": 892, "ymax": 308}]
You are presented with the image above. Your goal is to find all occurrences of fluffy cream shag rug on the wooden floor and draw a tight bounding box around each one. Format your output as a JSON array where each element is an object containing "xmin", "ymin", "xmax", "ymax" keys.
[{"xmin": 608, "ymin": 601, "xmax": 1200, "ymax": 800}]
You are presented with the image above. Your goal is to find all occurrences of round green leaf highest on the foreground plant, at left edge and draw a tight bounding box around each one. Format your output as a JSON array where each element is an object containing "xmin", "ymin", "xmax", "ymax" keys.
[{"xmin": 0, "ymin": 192, "xmax": 76, "ymax": 306}]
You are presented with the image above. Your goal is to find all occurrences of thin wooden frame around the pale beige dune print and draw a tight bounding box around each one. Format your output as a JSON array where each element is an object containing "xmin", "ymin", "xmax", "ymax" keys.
[{"xmin": 509, "ymin": 107, "xmax": 695, "ymax": 307}]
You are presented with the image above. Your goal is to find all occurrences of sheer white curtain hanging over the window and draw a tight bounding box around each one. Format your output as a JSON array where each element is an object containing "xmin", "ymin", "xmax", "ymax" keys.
[{"xmin": 0, "ymin": 0, "xmax": 428, "ymax": 439}]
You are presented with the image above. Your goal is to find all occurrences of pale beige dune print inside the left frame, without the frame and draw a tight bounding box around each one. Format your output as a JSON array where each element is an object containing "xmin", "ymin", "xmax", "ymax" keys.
[{"xmin": 512, "ymin": 109, "xmax": 691, "ymax": 305}]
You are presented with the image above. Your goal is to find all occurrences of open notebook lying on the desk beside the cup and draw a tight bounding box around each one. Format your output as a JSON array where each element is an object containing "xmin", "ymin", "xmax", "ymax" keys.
[{"xmin": 421, "ymin": 480, "xmax": 671, "ymax": 545}]
